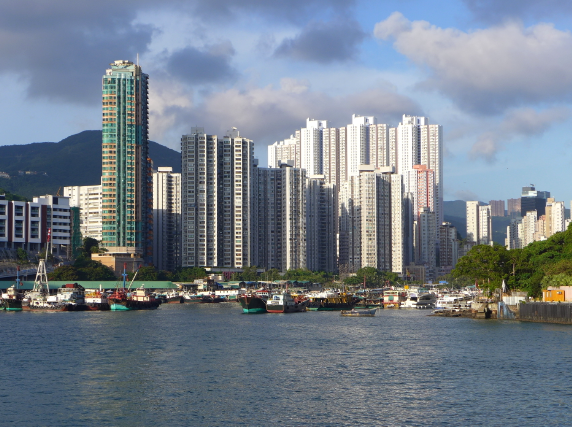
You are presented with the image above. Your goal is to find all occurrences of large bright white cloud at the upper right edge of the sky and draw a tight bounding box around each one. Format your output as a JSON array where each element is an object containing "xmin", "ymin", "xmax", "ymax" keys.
[{"xmin": 374, "ymin": 12, "xmax": 572, "ymax": 114}]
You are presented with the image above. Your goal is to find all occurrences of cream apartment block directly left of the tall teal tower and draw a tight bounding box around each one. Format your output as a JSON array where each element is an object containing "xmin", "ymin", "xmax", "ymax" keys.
[{"xmin": 63, "ymin": 185, "xmax": 102, "ymax": 241}]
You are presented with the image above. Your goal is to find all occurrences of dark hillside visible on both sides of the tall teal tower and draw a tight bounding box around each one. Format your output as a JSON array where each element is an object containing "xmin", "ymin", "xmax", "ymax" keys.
[{"xmin": 0, "ymin": 130, "xmax": 181, "ymax": 199}]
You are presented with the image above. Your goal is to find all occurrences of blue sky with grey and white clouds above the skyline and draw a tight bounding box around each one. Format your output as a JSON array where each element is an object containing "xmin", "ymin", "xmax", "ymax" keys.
[{"xmin": 0, "ymin": 0, "xmax": 572, "ymax": 206}]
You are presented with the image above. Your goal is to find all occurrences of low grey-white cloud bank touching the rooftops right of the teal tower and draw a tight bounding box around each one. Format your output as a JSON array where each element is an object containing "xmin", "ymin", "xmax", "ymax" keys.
[{"xmin": 146, "ymin": 78, "xmax": 421, "ymax": 154}]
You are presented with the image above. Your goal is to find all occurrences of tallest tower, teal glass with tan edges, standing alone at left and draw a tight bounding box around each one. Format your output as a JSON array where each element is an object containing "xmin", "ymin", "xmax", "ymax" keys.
[{"xmin": 101, "ymin": 61, "xmax": 153, "ymax": 260}]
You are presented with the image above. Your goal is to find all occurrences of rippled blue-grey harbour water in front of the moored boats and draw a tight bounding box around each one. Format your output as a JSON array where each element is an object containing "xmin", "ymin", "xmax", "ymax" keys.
[{"xmin": 0, "ymin": 303, "xmax": 572, "ymax": 427}]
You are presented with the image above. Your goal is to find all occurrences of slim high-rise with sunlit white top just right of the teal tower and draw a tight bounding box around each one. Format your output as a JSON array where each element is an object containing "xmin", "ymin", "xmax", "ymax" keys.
[{"xmin": 153, "ymin": 167, "xmax": 182, "ymax": 271}]
